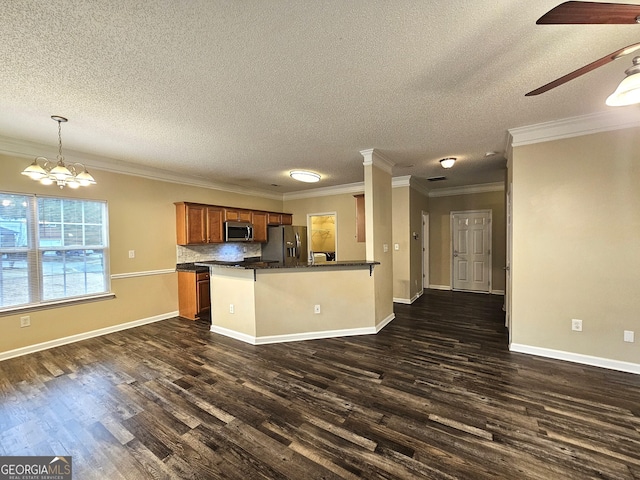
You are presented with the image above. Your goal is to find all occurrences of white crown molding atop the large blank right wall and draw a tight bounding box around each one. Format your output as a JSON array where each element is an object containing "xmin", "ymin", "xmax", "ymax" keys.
[{"xmin": 507, "ymin": 105, "xmax": 640, "ymax": 147}]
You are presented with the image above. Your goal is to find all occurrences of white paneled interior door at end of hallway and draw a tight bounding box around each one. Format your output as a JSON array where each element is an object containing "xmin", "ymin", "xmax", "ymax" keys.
[{"xmin": 451, "ymin": 210, "xmax": 491, "ymax": 292}]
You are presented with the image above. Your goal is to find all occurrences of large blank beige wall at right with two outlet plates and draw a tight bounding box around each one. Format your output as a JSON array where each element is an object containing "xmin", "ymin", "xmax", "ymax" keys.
[{"xmin": 511, "ymin": 129, "xmax": 640, "ymax": 364}]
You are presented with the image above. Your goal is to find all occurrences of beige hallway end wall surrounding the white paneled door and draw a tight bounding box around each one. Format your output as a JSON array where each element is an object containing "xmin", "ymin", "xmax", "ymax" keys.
[{"xmin": 429, "ymin": 191, "xmax": 506, "ymax": 292}]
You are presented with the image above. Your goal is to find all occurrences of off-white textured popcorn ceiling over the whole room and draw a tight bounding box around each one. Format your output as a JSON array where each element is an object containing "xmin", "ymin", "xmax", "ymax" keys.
[{"xmin": 0, "ymin": 0, "xmax": 640, "ymax": 193}]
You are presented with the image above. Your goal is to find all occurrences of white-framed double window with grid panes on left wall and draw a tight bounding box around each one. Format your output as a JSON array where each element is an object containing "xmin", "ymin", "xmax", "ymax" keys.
[{"xmin": 0, "ymin": 192, "xmax": 109, "ymax": 310}]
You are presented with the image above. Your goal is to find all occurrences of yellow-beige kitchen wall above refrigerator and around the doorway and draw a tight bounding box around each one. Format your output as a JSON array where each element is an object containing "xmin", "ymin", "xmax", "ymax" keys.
[{"xmin": 283, "ymin": 193, "xmax": 365, "ymax": 260}]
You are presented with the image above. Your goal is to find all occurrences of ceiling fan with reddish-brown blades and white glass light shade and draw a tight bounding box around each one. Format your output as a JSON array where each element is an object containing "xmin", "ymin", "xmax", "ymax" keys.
[{"xmin": 525, "ymin": 1, "xmax": 640, "ymax": 105}]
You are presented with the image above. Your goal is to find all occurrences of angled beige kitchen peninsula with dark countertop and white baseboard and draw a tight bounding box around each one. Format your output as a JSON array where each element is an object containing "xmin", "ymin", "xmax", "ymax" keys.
[{"xmin": 197, "ymin": 261, "xmax": 380, "ymax": 345}]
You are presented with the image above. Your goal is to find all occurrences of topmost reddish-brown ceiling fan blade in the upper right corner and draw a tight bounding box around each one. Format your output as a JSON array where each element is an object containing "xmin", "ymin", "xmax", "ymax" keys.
[{"xmin": 536, "ymin": 2, "xmax": 640, "ymax": 25}]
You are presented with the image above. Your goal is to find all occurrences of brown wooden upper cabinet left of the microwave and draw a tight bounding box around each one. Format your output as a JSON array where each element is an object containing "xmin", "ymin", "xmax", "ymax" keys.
[{"xmin": 175, "ymin": 202, "xmax": 224, "ymax": 245}]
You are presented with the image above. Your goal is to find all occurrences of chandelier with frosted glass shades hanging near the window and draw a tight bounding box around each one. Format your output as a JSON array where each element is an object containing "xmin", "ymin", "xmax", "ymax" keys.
[{"xmin": 22, "ymin": 115, "xmax": 96, "ymax": 188}]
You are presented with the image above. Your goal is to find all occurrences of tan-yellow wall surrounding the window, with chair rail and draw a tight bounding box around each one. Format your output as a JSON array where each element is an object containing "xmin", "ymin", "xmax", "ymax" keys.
[{"xmin": 0, "ymin": 152, "xmax": 282, "ymax": 354}]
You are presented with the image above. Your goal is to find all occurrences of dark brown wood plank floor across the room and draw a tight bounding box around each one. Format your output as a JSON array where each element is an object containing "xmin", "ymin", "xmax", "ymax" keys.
[{"xmin": 0, "ymin": 290, "xmax": 640, "ymax": 480}]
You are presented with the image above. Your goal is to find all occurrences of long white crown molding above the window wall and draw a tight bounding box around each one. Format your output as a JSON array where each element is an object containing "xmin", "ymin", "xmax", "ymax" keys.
[{"xmin": 0, "ymin": 136, "xmax": 282, "ymax": 200}]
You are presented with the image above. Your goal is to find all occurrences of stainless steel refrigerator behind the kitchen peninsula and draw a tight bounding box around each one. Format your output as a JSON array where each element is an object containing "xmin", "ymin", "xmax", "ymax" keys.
[{"xmin": 262, "ymin": 225, "xmax": 309, "ymax": 265}]
